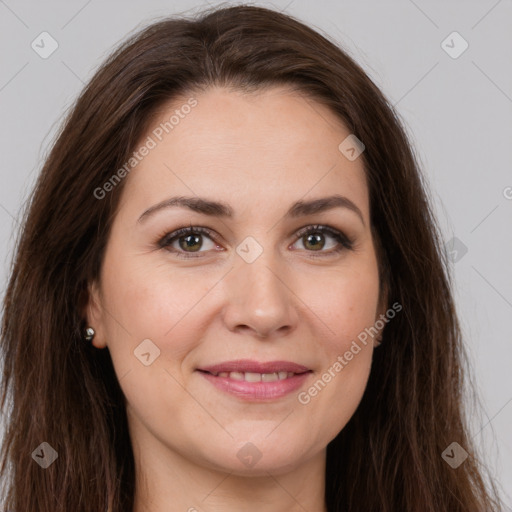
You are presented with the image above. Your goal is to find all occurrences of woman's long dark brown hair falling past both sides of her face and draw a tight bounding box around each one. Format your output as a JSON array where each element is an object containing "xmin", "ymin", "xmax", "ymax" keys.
[{"xmin": 0, "ymin": 5, "xmax": 500, "ymax": 512}]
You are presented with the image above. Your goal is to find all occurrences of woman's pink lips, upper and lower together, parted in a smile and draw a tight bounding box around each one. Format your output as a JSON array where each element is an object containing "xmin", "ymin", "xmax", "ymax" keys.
[{"xmin": 198, "ymin": 359, "xmax": 312, "ymax": 402}]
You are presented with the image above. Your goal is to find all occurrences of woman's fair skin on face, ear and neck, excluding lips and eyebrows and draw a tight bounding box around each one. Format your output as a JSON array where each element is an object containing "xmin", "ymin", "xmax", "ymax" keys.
[{"xmin": 87, "ymin": 87, "xmax": 385, "ymax": 512}]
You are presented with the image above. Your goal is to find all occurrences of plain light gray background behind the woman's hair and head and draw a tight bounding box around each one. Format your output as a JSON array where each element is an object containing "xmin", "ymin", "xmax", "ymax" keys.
[{"xmin": 0, "ymin": 0, "xmax": 512, "ymax": 506}]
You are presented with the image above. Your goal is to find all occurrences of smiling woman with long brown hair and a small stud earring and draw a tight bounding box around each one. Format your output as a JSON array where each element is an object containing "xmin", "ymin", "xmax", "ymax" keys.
[{"xmin": 2, "ymin": 6, "xmax": 499, "ymax": 512}]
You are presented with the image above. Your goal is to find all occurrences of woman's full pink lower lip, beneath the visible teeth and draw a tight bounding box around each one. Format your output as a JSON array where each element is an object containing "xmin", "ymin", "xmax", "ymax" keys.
[{"xmin": 199, "ymin": 371, "xmax": 311, "ymax": 401}]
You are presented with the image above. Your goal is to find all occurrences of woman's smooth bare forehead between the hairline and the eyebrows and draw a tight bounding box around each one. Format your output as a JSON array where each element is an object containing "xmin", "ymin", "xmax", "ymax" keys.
[{"xmin": 118, "ymin": 87, "xmax": 368, "ymax": 223}]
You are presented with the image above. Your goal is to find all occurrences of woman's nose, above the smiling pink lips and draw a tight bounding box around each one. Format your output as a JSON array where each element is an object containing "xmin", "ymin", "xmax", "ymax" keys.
[{"xmin": 223, "ymin": 252, "xmax": 300, "ymax": 338}]
